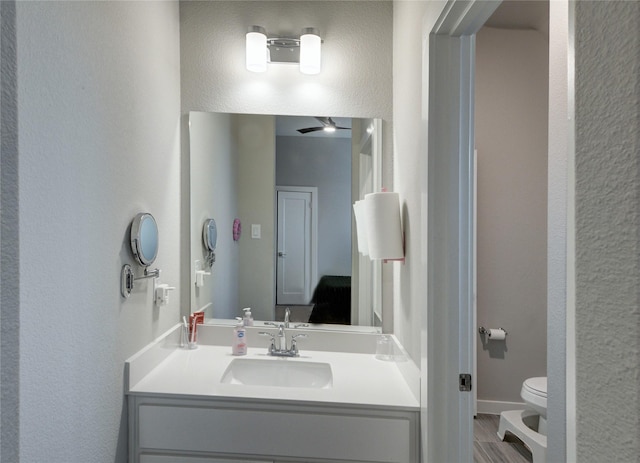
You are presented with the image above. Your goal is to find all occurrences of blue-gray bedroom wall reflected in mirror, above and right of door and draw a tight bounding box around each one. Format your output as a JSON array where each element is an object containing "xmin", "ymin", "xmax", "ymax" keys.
[{"xmin": 276, "ymin": 136, "xmax": 351, "ymax": 278}]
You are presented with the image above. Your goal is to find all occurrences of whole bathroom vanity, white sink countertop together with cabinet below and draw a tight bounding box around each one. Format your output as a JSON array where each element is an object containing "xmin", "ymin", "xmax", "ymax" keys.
[{"xmin": 126, "ymin": 326, "xmax": 420, "ymax": 463}]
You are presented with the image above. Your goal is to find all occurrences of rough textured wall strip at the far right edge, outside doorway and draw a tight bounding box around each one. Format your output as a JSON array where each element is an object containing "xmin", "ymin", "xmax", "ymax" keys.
[{"xmin": 575, "ymin": 2, "xmax": 640, "ymax": 462}]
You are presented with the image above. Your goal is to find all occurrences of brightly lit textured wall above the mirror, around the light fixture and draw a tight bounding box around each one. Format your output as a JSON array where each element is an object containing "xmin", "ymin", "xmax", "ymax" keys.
[{"xmin": 180, "ymin": 1, "xmax": 392, "ymax": 121}]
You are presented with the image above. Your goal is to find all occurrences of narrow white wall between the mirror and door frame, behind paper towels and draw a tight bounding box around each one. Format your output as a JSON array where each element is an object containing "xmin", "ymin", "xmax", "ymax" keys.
[{"xmin": 385, "ymin": 1, "xmax": 432, "ymax": 364}]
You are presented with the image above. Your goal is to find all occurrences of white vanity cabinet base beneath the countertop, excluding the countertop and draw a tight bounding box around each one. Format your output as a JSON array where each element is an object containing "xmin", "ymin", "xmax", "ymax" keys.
[{"xmin": 129, "ymin": 394, "xmax": 419, "ymax": 463}]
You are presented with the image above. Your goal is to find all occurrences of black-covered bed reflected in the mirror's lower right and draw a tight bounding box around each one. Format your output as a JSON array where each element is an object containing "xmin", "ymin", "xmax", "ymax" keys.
[{"xmin": 309, "ymin": 275, "xmax": 351, "ymax": 325}]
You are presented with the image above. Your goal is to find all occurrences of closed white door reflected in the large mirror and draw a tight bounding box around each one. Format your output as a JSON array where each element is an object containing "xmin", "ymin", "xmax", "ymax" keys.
[{"xmin": 276, "ymin": 190, "xmax": 313, "ymax": 305}]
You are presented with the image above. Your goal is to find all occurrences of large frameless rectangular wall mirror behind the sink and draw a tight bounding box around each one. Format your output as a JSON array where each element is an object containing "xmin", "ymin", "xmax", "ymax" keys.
[{"xmin": 189, "ymin": 112, "xmax": 382, "ymax": 330}]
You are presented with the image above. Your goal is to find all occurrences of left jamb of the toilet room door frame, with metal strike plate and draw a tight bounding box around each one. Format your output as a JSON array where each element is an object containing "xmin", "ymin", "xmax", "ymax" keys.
[{"xmin": 423, "ymin": 0, "xmax": 501, "ymax": 462}]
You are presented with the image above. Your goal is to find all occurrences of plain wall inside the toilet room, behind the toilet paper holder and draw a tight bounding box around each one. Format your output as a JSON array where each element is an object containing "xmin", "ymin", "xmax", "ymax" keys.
[{"xmin": 475, "ymin": 27, "xmax": 549, "ymax": 404}]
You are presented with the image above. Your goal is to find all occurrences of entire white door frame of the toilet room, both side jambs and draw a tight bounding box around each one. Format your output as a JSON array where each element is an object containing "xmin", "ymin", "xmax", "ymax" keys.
[{"xmin": 422, "ymin": 0, "xmax": 576, "ymax": 462}]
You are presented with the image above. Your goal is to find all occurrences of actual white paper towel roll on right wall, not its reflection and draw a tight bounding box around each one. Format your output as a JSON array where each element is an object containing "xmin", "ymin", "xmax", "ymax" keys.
[{"xmin": 364, "ymin": 192, "xmax": 404, "ymax": 259}]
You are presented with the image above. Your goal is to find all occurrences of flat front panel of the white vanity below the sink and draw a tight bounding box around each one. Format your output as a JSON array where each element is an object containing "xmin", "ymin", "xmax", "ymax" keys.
[{"xmin": 137, "ymin": 404, "xmax": 415, "ymax": 463}]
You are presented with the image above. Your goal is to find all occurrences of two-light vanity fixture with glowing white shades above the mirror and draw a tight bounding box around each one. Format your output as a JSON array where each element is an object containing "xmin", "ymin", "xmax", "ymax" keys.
[{"xmin": 246, "ymin": 26, "xmax": 322, "ymax": 74}]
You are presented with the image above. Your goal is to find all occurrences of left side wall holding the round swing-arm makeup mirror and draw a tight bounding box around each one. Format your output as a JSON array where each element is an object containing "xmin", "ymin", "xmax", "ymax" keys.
[{"xmin": 15, "ymin": 2, "xmax": 180, "ymax": 463}]
